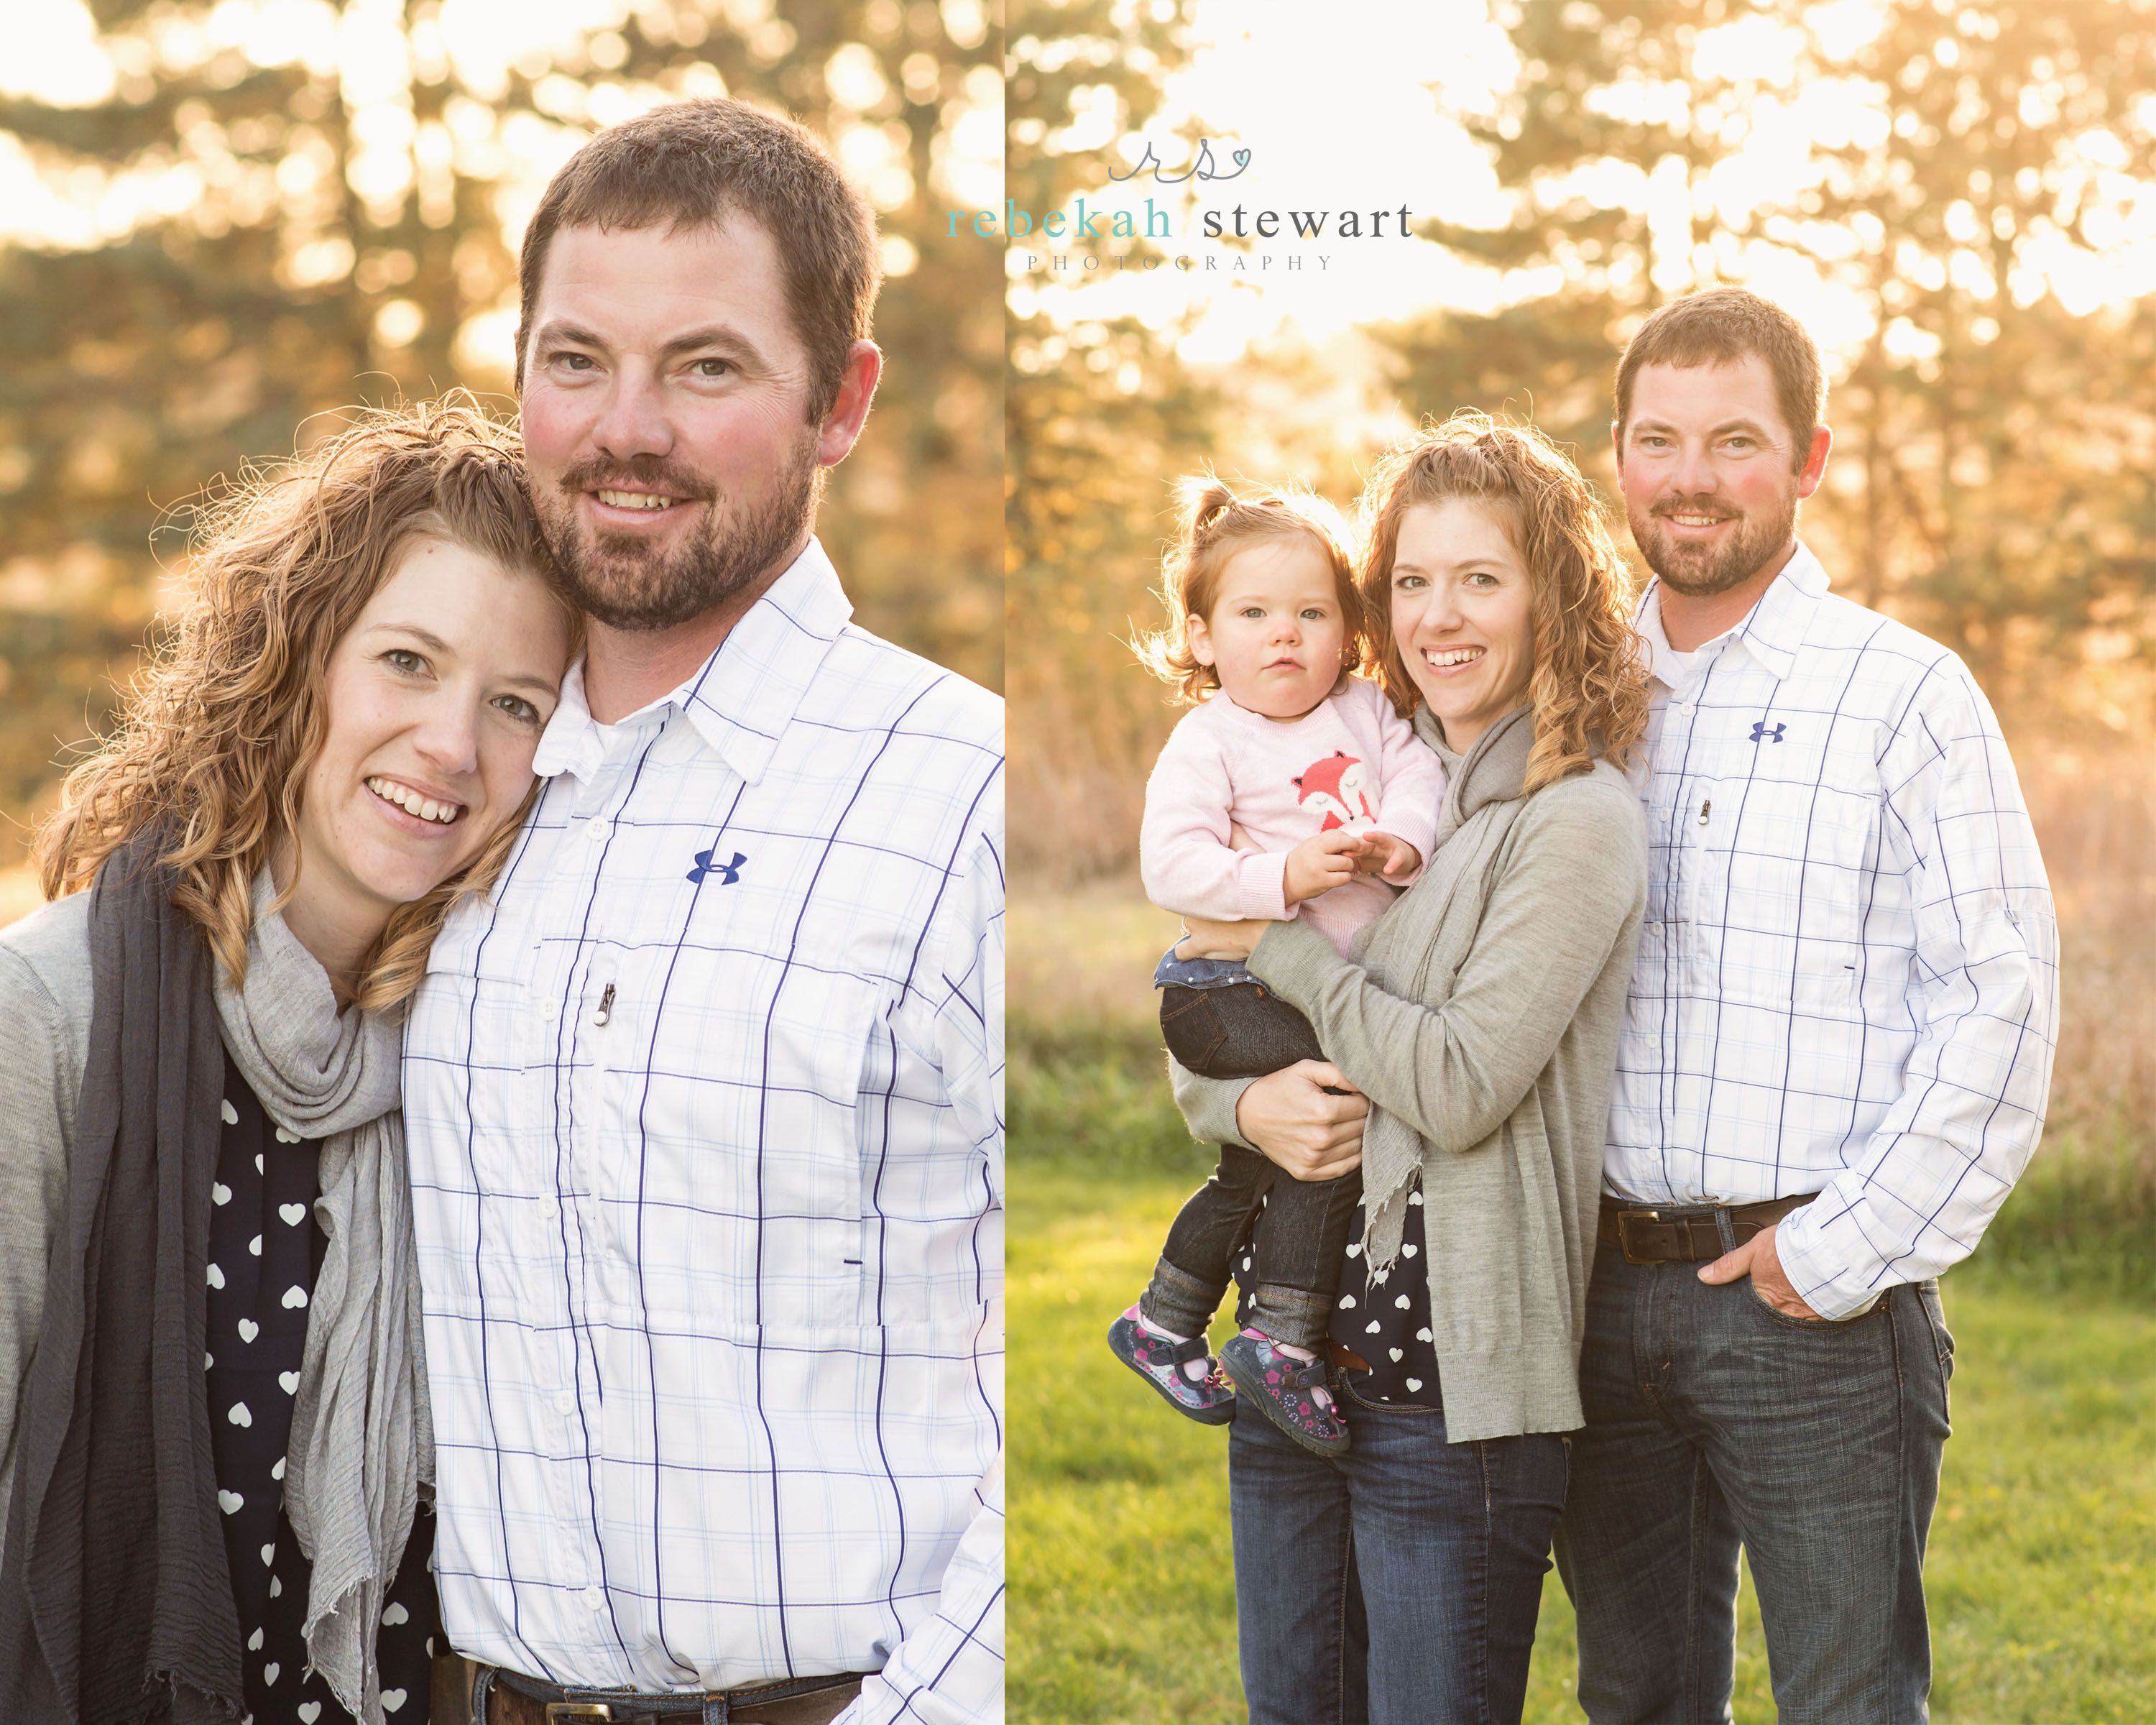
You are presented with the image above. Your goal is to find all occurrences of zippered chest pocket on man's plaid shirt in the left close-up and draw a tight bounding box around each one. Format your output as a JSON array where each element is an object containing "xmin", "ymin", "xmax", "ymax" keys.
[{"xmin": 595, "ymin": 951, "xmax": 882, "ymax": 1330}]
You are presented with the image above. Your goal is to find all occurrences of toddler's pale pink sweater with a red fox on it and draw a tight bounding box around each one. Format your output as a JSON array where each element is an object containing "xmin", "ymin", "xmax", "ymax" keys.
[{"xmin": 1138, "ymin": 677, "xmax": 1445, "ymax": 955}]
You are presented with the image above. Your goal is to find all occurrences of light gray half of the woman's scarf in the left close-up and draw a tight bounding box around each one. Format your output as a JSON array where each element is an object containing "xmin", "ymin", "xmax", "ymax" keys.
[{"xmin": 216, "ymin": 869, "xmax": 433, "ymax": 1725}]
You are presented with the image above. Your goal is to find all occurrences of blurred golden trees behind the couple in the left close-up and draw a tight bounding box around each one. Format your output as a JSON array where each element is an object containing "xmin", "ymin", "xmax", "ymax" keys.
[{"xmin": 0, "ymin": 0, "xmax": 1003, "ymax": 862}]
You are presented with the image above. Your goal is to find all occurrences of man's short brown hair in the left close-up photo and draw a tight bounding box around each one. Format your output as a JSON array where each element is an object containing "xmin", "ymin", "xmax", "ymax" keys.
[{"xmin": 517, "ymin": 97, "xmax": 880, "ymax": 425}]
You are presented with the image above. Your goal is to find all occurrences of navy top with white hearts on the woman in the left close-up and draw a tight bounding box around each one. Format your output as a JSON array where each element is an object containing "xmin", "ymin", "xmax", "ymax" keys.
[{"xmin": 205, "ymin": 1054, "xmax": 440, "ymax": 1725}]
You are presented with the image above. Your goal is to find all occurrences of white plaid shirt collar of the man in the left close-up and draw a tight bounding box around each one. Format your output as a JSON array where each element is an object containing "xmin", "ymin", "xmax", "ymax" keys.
[{"xmin": 533, "ymin": 539, "xmax": 854, "ymax": 785}]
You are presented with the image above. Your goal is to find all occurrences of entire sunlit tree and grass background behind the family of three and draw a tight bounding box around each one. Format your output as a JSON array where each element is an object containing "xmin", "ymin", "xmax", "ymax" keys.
[{"xmin": 1005, "ymin": 0, "xmax": 2156, "ymax": 1725}]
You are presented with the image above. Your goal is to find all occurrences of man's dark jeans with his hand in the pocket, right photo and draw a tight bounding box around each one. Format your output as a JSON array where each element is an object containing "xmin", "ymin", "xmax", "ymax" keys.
[{"xmin": 1557, "ymin": 1246, "xmax": 1953, "ymax": 1725}]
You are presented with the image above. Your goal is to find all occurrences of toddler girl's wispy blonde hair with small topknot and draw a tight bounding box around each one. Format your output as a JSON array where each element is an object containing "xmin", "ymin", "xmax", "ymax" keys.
[{"xmin": 1130, "ymin": 472, "xmax": 1369, "ymax": 707}]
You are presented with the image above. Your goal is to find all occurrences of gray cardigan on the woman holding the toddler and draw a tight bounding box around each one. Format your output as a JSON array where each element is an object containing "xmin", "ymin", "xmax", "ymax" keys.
[{"xmin": 1175, "ymin": 731, "xmax": 1647, "ymax": 1443}]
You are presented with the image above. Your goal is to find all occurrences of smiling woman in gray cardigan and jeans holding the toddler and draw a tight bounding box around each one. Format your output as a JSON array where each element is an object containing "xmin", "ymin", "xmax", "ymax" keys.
[{"xmin": 1147, "ymin": 412, "xmax": 1647, "ymax": 1725}]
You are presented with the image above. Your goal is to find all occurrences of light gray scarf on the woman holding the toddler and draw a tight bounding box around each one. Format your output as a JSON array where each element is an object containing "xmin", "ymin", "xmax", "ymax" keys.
[{"xmin": 1358, "ymin": 705, "xmax": 1535, "ymax": 1283}]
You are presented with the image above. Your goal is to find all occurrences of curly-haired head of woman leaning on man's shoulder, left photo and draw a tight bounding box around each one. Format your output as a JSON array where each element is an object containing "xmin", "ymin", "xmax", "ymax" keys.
[{"xmin": 39, "ymin": 405, "xmax": 578, "ymax": 1007}]
